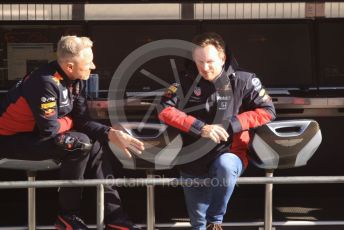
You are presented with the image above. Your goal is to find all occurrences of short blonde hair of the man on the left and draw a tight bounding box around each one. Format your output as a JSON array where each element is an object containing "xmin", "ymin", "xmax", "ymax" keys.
[{"xmin": 56, "ymin": 35, "xmax": 93, "ymax": 60}]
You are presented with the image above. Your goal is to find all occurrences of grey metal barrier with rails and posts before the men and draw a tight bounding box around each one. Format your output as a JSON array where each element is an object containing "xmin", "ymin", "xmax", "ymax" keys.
[{"xmin": 0, "ymin": 176, "xmax": 344, "ymax": 230}]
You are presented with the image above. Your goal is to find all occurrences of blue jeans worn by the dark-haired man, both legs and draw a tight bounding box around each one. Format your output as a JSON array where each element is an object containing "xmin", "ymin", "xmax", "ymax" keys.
[{"xmin": 181, "ymin": 153, "xmax": 243, "ymax": 230}]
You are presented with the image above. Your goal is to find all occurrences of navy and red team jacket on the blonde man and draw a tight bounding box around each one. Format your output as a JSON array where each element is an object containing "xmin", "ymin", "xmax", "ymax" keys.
[{"xmin": 0, "ymin": 61, "xmax": 109, "ymax": 140}]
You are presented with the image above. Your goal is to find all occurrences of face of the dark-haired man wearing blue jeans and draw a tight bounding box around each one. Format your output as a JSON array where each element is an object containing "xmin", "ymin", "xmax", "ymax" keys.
[{"xmin": 193, "ymin": 45, "xmax": 226, "ymax": 81}]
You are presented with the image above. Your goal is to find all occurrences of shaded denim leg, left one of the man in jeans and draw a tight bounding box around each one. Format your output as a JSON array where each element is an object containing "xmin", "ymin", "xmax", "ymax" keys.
[{"xmin": 181, "ymin": 172, "xmax": 211, "ymax": 230}]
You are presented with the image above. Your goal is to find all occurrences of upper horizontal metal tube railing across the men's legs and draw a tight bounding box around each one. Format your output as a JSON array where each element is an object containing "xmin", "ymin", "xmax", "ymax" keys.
[{"xmin": 0, "ymin": 176, "xmax": 344, "ymax": 189}]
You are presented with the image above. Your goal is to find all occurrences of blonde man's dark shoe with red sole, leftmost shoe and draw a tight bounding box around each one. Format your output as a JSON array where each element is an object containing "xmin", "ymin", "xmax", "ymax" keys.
[{"xmin": 55, "ymin": 214, "xmax": 89, "ymax": 230}]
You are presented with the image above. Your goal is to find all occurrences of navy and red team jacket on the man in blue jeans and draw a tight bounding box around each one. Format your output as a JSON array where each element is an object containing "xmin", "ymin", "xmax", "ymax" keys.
[{"xmin": 159, "ymin": 63, "xmax": 275, "ymax": 175}]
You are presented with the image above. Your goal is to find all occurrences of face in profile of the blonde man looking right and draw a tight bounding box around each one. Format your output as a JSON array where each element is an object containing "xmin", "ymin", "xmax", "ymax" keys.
[{"xmin": 70, "ymin": 48, "xmax": 96, "ymax": 80}]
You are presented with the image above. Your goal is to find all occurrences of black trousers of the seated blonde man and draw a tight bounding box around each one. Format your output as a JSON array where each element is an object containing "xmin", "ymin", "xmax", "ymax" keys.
[{"xmin": 0, "ymin": 132, "xmax": 127, "ymax": 223}]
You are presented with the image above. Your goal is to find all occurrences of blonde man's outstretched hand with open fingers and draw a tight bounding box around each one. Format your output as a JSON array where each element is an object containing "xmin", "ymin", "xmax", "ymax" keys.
[{"xmin": 108, "ymin": 128, "xmax": 145, "ymax": 158}]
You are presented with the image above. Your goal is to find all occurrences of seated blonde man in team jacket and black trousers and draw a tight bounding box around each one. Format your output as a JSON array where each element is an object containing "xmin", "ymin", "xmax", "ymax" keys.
[{"xmin": 0, "ymin": 36, "xmax": 144, "ymax": 229}]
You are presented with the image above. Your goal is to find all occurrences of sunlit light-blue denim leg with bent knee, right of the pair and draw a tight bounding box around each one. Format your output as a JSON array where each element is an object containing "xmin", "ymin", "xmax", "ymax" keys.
[{"xmin": 206, "ymin": 153, "xmax": 242, "ymax": 223}]
